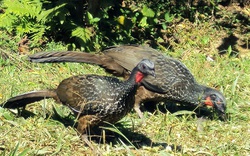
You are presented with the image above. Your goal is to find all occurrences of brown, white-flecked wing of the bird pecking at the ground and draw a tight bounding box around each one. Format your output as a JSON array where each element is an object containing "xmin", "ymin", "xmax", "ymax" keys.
[{"xmin": 104, "ymin": 45, "xmax": 196, "ymax": 93}]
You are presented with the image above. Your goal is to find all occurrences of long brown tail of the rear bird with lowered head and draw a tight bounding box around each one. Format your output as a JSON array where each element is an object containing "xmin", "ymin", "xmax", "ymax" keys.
[{"xmin": 29, "ymin": 51, "xmax": 102, "ymax": 65}]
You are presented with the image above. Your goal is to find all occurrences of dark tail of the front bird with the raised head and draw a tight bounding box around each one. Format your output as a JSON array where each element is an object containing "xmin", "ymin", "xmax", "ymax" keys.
[{"xmin": 1, "ymin": 90, "xmax": 58, "ymax": 109}]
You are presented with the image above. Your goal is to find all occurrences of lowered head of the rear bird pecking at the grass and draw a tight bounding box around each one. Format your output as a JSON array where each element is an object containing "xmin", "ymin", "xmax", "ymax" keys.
[{"xmin": 203, "ymin": 88, "xmax": 226, "ymax": 120}]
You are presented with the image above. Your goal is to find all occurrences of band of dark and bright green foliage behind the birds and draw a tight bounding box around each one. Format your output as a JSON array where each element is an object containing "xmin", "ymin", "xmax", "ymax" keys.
[{"xmin": 0, "ymin": 0, "xmax": 223, "ymax": 51}]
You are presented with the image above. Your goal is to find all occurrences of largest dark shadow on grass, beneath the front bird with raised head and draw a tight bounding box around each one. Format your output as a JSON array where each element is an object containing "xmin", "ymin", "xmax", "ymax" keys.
[{"xmin": 79, "ymin": 123, "xmax": 182, "ymax": 152}]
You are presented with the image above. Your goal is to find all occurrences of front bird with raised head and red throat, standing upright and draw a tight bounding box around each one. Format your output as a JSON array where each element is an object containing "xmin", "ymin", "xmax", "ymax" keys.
[{"xmin": 1, "ymin": 59, "xmax": 155, "ymax": 134}]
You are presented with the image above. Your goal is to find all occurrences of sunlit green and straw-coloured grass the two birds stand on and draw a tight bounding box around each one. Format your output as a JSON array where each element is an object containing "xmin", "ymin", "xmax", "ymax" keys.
[{"xmin": 0, "ymin": 8, "xmax": 250, "ymax": 156}]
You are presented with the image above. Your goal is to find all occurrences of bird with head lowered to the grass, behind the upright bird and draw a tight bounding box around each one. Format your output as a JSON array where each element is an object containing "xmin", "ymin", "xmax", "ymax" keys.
[{"xmin": 28, "ymin": 45, "xmax": 226, "ymax": 120}]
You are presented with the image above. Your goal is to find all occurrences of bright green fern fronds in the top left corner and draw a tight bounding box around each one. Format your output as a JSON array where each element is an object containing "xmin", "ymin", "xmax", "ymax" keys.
[{"xmin": 0, "ymin": 0, "xmax": 49, "ymax": 44}]
